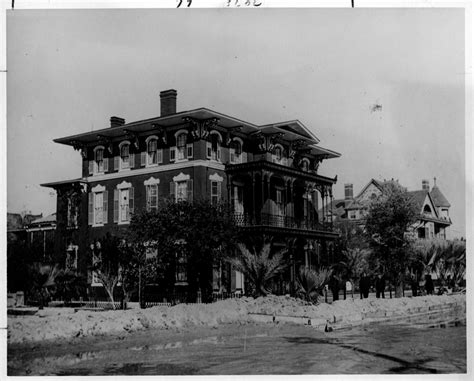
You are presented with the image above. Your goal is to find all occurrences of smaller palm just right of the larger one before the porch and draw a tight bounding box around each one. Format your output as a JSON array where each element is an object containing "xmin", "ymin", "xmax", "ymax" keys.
[{"xmin": 296, "ymin": 266, "xmax": 332, "ymax": 303}]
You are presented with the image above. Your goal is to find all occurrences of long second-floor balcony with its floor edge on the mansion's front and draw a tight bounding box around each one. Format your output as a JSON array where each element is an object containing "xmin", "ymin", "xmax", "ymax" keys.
[{"xmin": 234, "ymin": 213, "xmax": 337, "ymax": 238}]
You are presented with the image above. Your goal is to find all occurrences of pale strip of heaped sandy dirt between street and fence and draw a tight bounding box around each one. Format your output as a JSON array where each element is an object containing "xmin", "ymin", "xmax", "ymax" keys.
[{"xmin": 8, "ymin": 295, "xmax": 465, "ymax": 345}]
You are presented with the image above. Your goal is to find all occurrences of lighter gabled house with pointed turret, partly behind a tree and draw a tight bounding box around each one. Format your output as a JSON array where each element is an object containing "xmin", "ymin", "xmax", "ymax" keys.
[{"xmin": 331, "ymin": 178, "xmax": 451, "ymax": 239}]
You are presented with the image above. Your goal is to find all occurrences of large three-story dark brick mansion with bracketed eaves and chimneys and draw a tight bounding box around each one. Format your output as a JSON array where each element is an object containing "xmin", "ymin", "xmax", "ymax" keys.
[{"xmin": 43, "ymin": 90, "xmax": 340, "ymax": 291}]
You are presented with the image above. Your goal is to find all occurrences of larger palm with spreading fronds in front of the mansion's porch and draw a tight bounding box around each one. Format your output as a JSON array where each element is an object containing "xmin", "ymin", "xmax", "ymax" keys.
[{"xmin": 230, "ymin": 243, "xmax": 288, "ymax": 297}]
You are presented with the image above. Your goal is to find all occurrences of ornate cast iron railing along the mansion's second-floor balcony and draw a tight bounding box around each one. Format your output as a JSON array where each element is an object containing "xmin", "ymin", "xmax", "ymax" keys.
[{"xmin": 234, "ymin": 213, "xmax": 332, "ymax": 231}]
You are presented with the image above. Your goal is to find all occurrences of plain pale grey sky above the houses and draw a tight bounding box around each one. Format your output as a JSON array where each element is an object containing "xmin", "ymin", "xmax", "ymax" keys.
[{"xmin": 7, "ymin": 9, "xmax": 466, "ymax": 236}]
